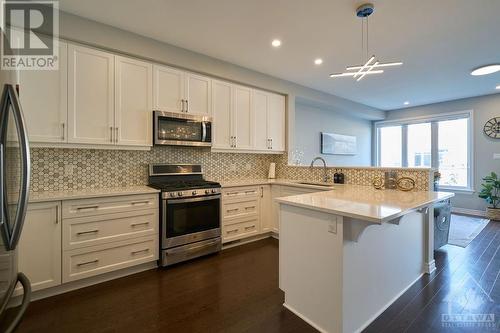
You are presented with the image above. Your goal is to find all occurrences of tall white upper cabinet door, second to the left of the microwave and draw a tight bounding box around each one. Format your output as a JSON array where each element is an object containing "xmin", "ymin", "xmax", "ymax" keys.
[{"xmin": 68, "ymin": 45, "xmax": 114, "ymax": 144}]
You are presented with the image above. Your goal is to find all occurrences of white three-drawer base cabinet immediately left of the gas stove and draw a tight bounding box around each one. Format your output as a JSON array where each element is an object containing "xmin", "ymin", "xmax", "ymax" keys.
[{"xmin": 62, "ymin": 194, "xmax": 159, "ymax": 283}]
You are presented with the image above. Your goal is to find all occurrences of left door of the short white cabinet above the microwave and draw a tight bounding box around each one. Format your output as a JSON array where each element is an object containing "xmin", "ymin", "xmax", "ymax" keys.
[{"xmin": 153, "ymin": 65, "xmax": 185, "ymax": 112}]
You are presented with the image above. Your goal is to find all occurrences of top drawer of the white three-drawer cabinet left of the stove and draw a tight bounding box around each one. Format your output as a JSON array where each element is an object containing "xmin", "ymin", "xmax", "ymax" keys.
[{"xmin": 62, "ymin": 194, "xmax": 158, "ymax": 218}]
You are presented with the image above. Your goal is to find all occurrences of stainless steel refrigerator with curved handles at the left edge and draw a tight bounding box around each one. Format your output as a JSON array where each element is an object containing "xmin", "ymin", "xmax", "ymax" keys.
[{"xmin": 0, "ymin": 81, "xmax": 31, "ymax": 332}]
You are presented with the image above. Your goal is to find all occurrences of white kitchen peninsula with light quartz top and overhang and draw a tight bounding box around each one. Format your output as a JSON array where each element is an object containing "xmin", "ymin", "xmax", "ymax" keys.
[{"xmin": 276, "ymin": 185, "xmax": 453, "ymax": 333}]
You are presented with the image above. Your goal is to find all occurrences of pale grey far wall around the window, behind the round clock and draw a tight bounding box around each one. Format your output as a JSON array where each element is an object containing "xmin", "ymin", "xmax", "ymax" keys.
[{"xmin": 386, "ymin": 94, "xmax": 500, "ymax": 210}]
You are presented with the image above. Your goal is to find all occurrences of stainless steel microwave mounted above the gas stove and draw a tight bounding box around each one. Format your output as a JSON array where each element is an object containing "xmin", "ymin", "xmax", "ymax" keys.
[{"xmin": 153, "ymin": 111, "xmax": 212, "ymax": 147}]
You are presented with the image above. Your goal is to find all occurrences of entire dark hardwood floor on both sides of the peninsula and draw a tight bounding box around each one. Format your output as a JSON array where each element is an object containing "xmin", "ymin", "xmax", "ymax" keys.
[{"xmin": 9, "ymin": 222, "xmax": 500, "ymax": 333}]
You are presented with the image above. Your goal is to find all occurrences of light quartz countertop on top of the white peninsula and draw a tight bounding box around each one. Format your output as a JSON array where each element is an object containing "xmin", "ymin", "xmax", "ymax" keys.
[{"xmin": 276, "ymin": 185, "xmax": 454, "ymax": 224}]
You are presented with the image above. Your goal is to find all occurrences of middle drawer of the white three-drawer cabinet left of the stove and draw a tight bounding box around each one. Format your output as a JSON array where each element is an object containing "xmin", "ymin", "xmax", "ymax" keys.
[{"xmin": 63, "ymin": 209, "xmax": 159, "ymax": 250}]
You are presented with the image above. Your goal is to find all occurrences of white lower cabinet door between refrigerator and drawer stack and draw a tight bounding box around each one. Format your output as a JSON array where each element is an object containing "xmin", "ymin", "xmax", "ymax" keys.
[{"xmin": 18, "ymin": 201, "xmax": 62, "ymax": 291}]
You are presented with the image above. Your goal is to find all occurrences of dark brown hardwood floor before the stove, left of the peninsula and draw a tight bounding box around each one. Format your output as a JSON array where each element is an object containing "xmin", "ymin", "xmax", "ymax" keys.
[{"xmin": 18, "ymin": 239, "xmax": 316, "ymax": 333}]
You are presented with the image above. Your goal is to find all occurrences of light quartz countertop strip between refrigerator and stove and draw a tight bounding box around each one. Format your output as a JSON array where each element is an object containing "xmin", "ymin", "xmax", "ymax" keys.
[{"xmin": 29, "ymin": 186, "xmax": 160, "ymax": 202}]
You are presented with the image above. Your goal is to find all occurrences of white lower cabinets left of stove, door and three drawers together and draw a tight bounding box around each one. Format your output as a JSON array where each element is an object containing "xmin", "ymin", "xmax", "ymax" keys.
[{"xmin": 16, "ymin": 193, "xmax": 159, "ymax": 294}]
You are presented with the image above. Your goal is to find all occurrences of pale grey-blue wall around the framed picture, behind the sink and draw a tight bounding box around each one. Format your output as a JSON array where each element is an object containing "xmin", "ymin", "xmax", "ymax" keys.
[{"xmin": 291, "ymin": 103, "xmax": 372, "ymax": 166}]
